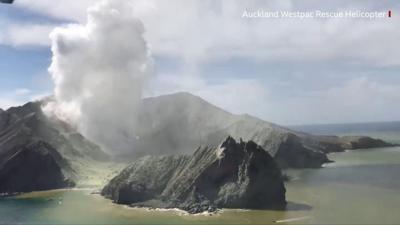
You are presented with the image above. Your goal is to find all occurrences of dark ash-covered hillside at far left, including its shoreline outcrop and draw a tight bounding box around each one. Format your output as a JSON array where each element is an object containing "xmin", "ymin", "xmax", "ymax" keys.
[{"xmin": 0, "ymin": 102, "xmax": 108, "ymax": 192}]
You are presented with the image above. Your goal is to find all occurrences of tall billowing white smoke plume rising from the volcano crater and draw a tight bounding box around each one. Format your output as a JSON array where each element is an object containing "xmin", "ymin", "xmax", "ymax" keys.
[{"xmin": 45, "ymin": 0, "xmax": 153, "ymax": 151}]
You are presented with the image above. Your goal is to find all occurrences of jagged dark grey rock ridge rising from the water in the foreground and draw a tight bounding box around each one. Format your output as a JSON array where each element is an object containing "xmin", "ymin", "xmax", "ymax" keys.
[{"xmin": 102, "ymin": 137, "xmax": 286, "ymax": 213}]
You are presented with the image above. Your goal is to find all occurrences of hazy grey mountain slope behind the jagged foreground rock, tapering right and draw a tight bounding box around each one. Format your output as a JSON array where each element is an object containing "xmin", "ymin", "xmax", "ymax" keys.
[{"xmin": 129, "ymin": 93, "xmax": 394, "ymax": 168}]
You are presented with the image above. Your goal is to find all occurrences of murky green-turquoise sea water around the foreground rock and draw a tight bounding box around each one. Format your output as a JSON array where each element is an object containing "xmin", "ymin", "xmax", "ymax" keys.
[{"xmin": 0, "ymin": 133, "xmax": 400, "ymax": 224}]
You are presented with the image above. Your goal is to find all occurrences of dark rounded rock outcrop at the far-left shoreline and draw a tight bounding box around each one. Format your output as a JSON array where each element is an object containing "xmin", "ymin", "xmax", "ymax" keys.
[{"xmin": 0, "ymin": 141, "xmax": 74, "ymax": 193}]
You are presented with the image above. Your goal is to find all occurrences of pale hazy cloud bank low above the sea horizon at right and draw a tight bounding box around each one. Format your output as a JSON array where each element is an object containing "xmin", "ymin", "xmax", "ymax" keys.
[{"xmin": 263, "ymin": 77, "xmax": 400, "ymax": 124}]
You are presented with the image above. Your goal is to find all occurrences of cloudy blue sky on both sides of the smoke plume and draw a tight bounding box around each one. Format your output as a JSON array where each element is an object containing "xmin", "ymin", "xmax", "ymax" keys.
[{"xmin": 0, "ymin": 0, "xmax": 400, "ymax": 125}]
